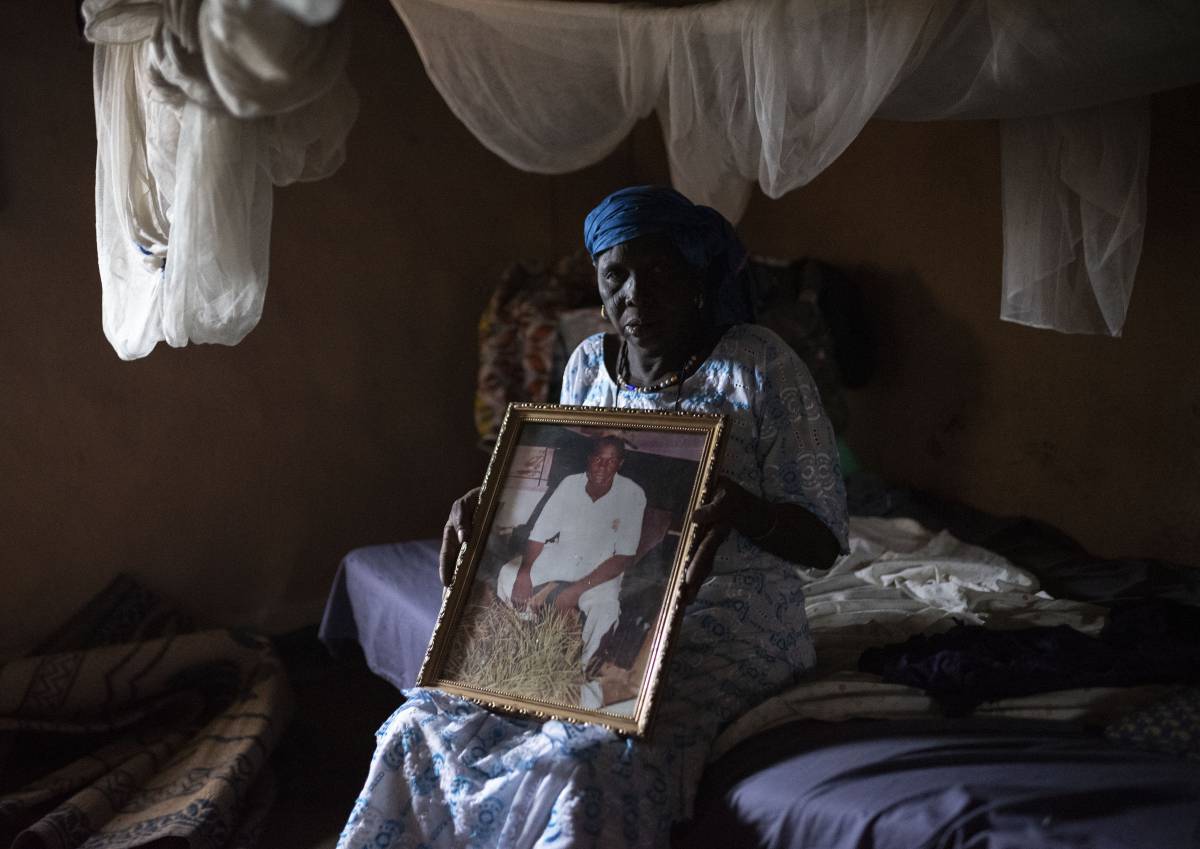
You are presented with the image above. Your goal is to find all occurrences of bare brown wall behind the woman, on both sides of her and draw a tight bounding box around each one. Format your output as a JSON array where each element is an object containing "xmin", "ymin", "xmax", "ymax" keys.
[{"xmin": 0, "ymin": 0, "xmax": 1200, "ymax": 655}]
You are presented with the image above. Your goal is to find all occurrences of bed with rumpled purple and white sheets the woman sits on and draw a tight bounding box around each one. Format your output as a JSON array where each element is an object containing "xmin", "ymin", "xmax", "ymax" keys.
[{"xmin": 320, "ymin": 475, "xmax": 1200, "ymax": 849}]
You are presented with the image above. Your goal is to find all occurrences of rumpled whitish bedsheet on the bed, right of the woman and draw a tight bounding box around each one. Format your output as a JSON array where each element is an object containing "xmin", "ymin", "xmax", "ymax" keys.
[{"xmin": 710, "ymin": 517, "xmax": 1128, "ymax": 759}]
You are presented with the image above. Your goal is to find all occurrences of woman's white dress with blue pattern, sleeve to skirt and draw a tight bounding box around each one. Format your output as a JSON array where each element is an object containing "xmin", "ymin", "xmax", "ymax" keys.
[{"xmin": 338, "ymin": 325, "xmax": 847, "ymax": 849}]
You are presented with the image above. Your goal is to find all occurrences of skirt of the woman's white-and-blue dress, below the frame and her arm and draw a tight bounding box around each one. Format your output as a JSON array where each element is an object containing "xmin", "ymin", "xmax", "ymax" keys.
[{"xmin": 338, "ymin": 563, "xmax": 814, "ymax": 849}]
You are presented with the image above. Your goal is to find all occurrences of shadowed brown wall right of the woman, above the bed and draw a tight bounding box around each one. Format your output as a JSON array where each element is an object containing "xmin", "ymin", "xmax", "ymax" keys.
[{"xmin": 743, "ymin": 86, "xmax": 1200, "ymax": 564}]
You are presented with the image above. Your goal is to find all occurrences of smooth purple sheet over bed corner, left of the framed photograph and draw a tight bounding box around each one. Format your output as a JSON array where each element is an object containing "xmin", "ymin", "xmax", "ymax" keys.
[{"xmin": 318, "ymin": 540, "xmax": 442, "ymax": 690}]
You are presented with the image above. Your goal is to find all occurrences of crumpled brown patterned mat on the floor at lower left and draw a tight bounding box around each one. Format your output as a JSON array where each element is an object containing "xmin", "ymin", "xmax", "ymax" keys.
[{"xmin": 0, "ymin": 578, "xmax": 292, "ymax": 849}]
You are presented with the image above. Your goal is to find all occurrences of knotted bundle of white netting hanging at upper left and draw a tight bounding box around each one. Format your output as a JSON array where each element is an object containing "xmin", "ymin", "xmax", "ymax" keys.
[{"xmin": 83, "ymin": 0, "xmax": 358, "ymax": 360}]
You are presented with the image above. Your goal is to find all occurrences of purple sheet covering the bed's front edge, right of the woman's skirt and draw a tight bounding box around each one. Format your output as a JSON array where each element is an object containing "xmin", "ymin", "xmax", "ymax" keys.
[{"xmin": 676, "ymin": 719, "xmax": 1200, "ymax": 849}]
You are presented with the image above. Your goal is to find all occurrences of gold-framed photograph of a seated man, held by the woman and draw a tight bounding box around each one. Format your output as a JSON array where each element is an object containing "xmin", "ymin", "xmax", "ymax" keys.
[{"xmin": 418, "ymin": 404, "xmax": 724, "ymax": 736}]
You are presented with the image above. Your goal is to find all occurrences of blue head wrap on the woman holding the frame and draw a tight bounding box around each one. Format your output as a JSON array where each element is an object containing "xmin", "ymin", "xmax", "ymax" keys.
[{"xmin": 583, "ymin": 186, "xmax": 751, "ymax": 324}]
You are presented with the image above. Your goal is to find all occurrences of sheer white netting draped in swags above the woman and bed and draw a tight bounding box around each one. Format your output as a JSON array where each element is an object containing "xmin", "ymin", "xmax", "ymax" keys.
[{"xmin": 391, "ymin": 0, "xmax": 1200, "ymax": 335}]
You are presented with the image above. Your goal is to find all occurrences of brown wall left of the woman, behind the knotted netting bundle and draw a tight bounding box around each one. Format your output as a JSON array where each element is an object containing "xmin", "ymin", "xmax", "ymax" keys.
[{"xmin": 0, "ymin": 0, "xmax": 630, "ymax": 654}]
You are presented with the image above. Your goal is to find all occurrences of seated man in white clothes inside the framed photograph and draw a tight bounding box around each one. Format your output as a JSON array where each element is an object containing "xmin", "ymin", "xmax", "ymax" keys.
[{"xmin": 497, "ymin": 436, "xmax": 646, "ymax": 709}]
